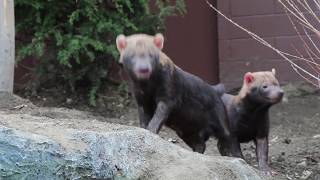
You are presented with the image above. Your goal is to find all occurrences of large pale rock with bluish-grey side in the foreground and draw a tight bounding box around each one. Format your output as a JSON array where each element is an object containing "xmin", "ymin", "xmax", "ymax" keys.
[{"xmin": 0, "ymin": 112, "xmax": 262, "ymax": 180}]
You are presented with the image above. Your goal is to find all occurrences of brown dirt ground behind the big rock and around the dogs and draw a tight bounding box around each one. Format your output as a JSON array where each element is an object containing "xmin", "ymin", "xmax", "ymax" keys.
[{"xmin": 10, "ymin": 85, "xmax": 320, "ymax": 180}]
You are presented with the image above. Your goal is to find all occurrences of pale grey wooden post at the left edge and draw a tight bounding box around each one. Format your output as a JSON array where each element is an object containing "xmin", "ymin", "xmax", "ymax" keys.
[{"xmin": 0, "ymin": 0, "xmax": 15, "ymax": 93}]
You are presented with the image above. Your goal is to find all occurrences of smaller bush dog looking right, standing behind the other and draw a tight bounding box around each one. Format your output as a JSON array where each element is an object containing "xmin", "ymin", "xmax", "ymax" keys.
[{"xmin": 213, "ymin": 69, "xmax": 283, "ymax": 175}]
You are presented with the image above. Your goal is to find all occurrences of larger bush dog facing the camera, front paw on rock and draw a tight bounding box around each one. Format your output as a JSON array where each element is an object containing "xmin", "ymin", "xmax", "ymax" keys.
[{"xmin": 117, "ymin": 34, "xmax": 240, "ymax": 156}]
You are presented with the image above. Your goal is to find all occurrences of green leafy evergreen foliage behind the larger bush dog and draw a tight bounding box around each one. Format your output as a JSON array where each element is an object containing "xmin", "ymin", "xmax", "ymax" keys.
[{"xmin": 15, "ymin": 0, "xmax": 185, "ymax": 105}]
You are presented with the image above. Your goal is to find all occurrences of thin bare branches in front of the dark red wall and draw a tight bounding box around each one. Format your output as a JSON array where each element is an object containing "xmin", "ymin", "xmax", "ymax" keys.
[{"xmin": 206, "ymin": 0, "xmax": 320, "ymax": 88}]
